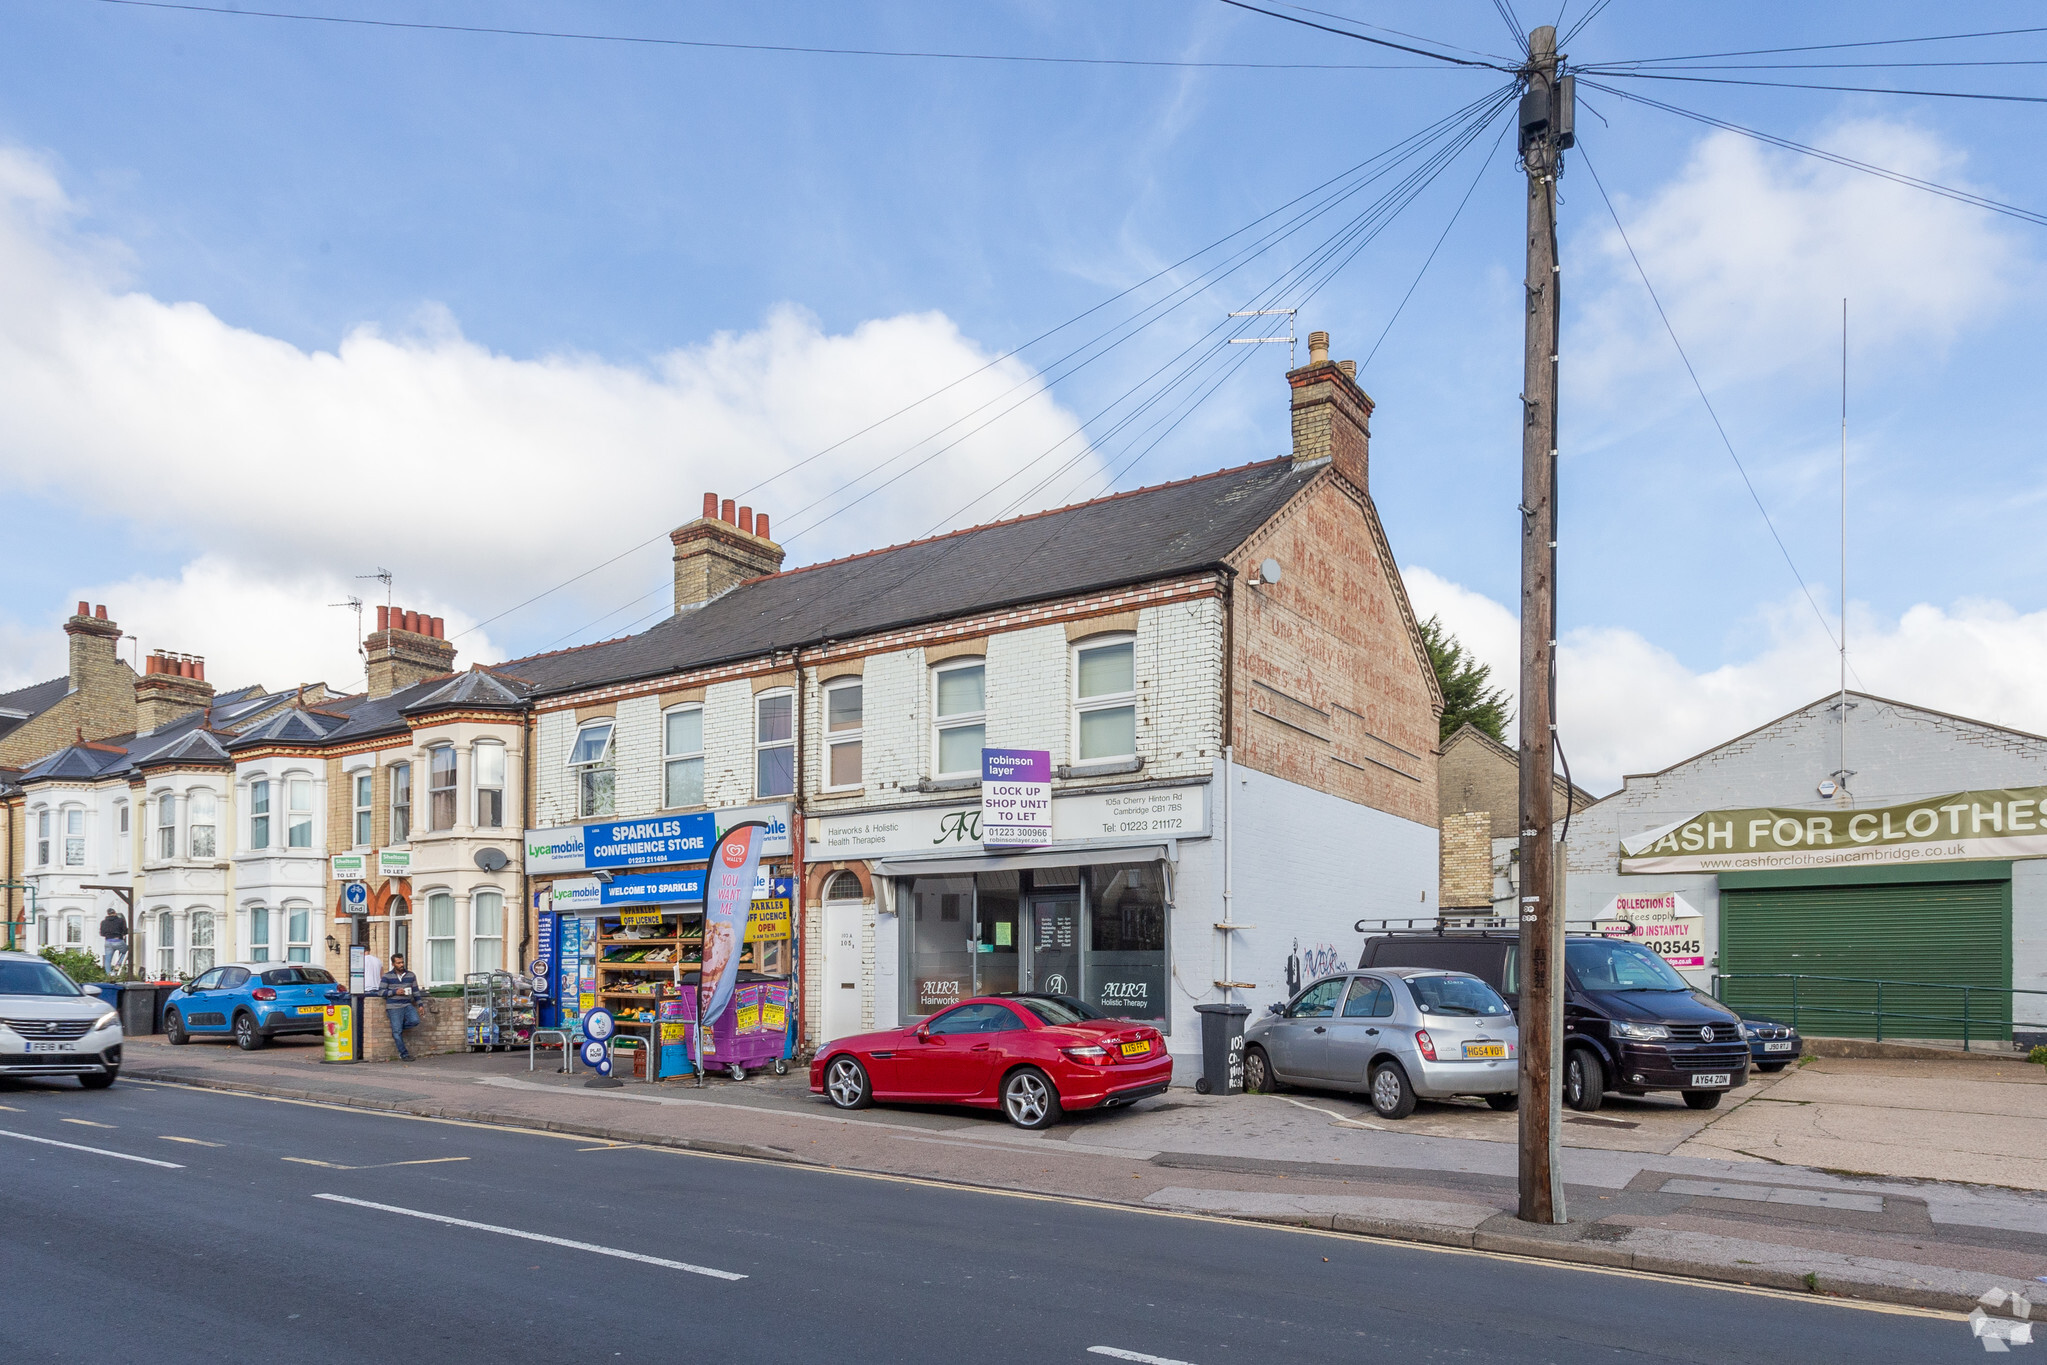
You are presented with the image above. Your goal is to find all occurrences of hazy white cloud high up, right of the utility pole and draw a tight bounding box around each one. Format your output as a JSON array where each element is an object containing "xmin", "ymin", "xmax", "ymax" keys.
[{"xmin": 1566, "ymin": 119, "xmax": 2029, "ymax": 413}]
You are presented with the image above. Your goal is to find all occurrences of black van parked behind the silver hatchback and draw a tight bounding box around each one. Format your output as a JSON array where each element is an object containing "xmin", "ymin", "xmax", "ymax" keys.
[{"xmin": 1357, "ymin": 923, "xmax": 1750, "ymax": 1111}]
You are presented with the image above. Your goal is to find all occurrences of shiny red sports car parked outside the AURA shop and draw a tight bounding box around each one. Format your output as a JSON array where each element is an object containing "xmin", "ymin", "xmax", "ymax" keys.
[{"xmin": 811, "ymin": 995, "xmax": 1173, "ymax": 1128}]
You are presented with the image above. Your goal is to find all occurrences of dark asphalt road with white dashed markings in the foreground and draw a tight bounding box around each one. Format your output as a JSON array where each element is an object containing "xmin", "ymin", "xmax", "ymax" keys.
[{"xmin": 0, "ymin": 1081, "xmax": 1981, "ymax": 1365}]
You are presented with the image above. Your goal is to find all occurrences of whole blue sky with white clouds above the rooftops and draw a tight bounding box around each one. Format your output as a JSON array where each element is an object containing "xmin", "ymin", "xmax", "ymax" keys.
[{"xmin": 0, "ymin": 0, "xmax": 2047, "ymax": 792}]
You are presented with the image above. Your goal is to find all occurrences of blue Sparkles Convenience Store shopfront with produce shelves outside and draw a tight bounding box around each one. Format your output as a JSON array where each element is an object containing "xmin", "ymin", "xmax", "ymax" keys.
[{"xmin": 526, "ymin": 804, "xmax": 798, "ymax": 1078}]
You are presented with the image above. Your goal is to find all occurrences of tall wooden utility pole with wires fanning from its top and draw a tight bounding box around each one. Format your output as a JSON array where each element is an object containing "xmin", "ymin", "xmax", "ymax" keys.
[{"xmin": 1519, "ymin": 25, "xmax": 1572, "ymax": 1224}]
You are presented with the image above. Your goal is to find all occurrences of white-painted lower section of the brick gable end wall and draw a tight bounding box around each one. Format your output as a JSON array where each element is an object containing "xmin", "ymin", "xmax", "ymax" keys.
[{"xmin": 1171, "ymin": 763, "xmax": 1439, "ymax": 1083}]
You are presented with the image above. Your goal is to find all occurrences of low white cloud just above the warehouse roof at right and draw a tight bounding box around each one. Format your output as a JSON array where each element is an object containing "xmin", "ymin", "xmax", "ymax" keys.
[{"xmin": 1402, "ymin": 567, "xmax": 2047, "ymax": 794}]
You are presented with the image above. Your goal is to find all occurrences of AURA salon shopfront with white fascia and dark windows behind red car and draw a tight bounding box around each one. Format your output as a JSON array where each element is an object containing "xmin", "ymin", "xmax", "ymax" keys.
[{"xmin": 804, "ymin": 784, "xmax": 1218, "ymax": 1042}]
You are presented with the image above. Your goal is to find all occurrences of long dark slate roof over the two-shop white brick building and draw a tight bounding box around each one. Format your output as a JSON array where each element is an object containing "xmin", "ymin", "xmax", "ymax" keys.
[{"xmin": 491, "ymin": 456, "xmax": 1320, "ymax": 696}]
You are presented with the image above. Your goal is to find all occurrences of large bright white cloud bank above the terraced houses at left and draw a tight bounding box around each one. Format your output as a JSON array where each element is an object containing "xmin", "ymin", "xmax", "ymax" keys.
[{"xmin": 0, "ymin": 147, "xmax": 1099, "ymax": 686}]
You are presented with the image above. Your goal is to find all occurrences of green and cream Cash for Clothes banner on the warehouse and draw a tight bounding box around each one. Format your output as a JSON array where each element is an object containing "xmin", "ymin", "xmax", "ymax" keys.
[{"xmin": 1621, "ymin": 786, "xmax": 2047, "ymax": 874}]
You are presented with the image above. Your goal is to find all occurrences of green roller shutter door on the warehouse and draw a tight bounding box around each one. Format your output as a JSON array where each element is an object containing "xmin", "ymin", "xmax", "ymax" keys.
[{"xmin": 1719, "ymin": 882, "xmax": 2012, "ymax": 1042}]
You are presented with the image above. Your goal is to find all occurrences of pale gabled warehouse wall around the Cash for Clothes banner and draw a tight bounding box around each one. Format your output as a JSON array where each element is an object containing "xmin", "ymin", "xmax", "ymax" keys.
[{"xmin": 1564, "ymin": 692, "xmax": 2047, "ymax": 1002}]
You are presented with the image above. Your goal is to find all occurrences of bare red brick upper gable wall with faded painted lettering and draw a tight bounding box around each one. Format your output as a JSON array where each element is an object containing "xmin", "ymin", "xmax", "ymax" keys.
[{"xmin": 1230, "ymin": 475, "xmax": 1441, "ymax": 827}]
